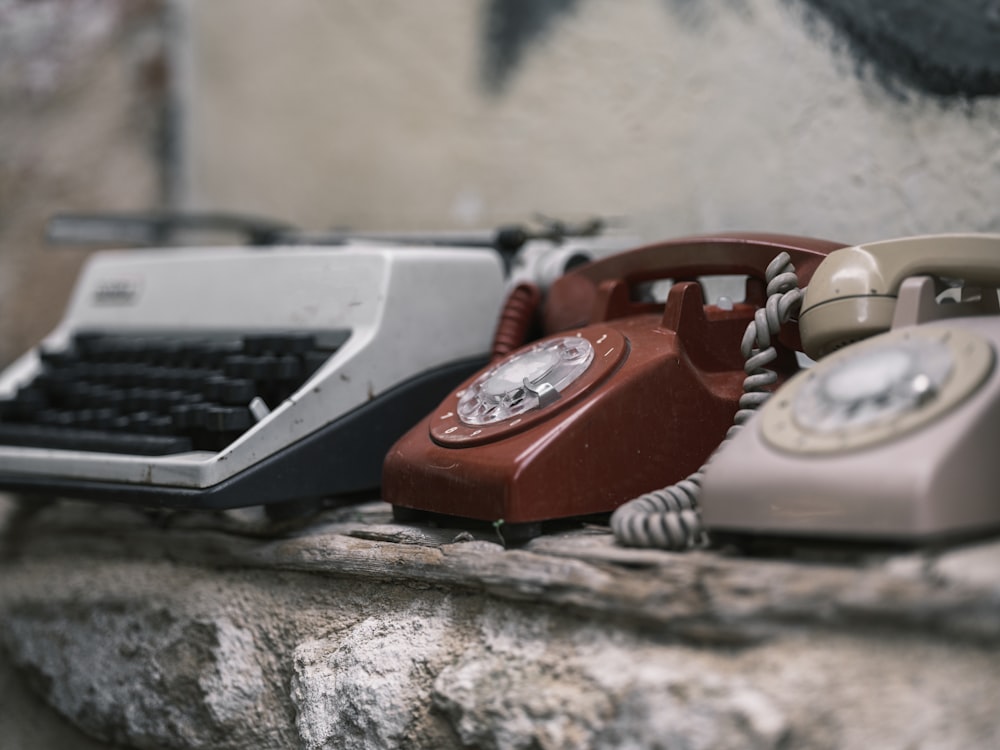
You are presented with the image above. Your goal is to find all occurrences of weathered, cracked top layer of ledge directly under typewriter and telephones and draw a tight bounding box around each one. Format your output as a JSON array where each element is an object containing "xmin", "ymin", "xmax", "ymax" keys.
[{"xmin": 9, "ymin": 503, "xmax": 1000, "ymax": 644}]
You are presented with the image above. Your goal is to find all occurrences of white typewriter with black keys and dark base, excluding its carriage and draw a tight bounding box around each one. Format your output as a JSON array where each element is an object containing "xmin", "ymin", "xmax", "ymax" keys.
[{"xmin": 0, "ymin": 242, "xmax": 504, "ymax": 509}]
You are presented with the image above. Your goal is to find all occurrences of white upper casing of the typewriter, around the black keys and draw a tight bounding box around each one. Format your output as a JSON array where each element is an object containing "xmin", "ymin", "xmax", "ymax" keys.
[{"xmin": 0, "ymin": 244, "xmax": 504, "ymax": 506}]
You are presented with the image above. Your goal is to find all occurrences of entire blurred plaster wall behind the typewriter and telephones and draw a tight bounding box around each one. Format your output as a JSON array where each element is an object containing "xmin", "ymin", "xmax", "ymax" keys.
[{"xmin": 0, "ymin": 0, "xmax": 1000, "ymax": 362}]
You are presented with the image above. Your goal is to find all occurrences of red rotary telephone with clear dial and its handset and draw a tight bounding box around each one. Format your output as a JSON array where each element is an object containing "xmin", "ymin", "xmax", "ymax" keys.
[{"xmin": 382, "ymin": 234, "xmax": 843, "ymax": 540}]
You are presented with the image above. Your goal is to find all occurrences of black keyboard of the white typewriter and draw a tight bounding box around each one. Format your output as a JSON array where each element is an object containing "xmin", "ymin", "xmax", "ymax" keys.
[{"xmin": 0, "ymin": 331, "xmax": 349, "ymax": 456}]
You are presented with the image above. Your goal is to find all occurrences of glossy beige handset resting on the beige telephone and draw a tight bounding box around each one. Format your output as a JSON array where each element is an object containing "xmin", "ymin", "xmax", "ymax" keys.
[{"xmin": 799, "ymin": 234, "xmax": 1000, "ymax": 359}]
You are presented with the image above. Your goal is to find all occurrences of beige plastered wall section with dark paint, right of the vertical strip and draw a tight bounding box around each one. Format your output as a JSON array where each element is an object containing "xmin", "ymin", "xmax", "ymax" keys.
[{"xmin": 186, "ymin": 0, "xmax": 1000, "ymax": 241}]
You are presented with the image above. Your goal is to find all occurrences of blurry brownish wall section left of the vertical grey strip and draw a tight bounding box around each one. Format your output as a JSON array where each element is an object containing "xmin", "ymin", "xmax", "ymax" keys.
[{"xmin": 0, "ymin": 0, "xmax": 167, "ymax": 366}]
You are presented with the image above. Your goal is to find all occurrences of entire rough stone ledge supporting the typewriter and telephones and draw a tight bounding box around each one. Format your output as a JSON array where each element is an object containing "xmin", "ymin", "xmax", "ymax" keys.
[{"xmin": 0, "ymin": 496, "xmax": 1000, "ymax": 750}]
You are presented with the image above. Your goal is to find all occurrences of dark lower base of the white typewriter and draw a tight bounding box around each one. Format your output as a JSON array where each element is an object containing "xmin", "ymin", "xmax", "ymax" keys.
[{"xmin": 0, "ymin": 358, "xmax": 486, "ymax": 510}]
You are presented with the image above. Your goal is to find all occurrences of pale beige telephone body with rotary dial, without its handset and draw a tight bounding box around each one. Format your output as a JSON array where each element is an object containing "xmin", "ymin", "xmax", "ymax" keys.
[{"xmin": 700, "ymin": 316, "xmax": 1000, "ymax": 547}]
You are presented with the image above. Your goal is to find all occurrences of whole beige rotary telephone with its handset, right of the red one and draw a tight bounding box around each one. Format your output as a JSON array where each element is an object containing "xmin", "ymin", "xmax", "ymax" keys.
[{"xmin": 700, "ymin": 234, "xmax": 1000, "ymax": 544}]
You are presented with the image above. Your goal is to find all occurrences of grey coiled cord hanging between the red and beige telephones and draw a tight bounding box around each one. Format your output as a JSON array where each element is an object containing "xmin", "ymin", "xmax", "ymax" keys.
[{"xmin": 611, "ymin": 252, "xmax": 804, "ymax": 550}]
